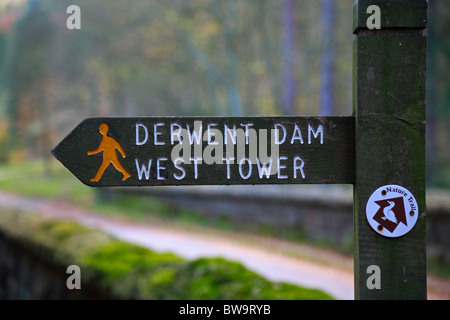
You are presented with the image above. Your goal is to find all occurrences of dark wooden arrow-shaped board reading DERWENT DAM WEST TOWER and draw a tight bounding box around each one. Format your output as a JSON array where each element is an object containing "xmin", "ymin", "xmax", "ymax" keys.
[{"xmin": 52, "ymin": 117, "xmax": 354, "ymax": 187}]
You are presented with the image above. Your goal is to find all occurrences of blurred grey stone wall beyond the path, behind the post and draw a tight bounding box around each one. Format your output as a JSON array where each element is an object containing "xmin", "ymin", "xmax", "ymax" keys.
[{"xmin": 105, "ymin": 185, "xmax": 450, "ymax": 264}]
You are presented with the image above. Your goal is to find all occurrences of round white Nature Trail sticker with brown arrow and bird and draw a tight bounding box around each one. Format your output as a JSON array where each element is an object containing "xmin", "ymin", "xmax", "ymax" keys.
[{"xmin": 366, "ymin": 185, "xmax": 419, "ymax": 238}]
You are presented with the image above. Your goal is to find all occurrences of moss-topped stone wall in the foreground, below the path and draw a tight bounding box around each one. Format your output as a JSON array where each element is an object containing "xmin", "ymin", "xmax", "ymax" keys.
[{"xmin": 0, "ymin": 208, "xmax": 331, "ymax": 300}]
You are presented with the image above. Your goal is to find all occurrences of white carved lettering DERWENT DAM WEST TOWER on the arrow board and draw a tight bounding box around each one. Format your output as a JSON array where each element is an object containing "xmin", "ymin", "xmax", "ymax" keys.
[{"xmin": 134, "ymin": 120, "xmax": 326, "ymax": 181}]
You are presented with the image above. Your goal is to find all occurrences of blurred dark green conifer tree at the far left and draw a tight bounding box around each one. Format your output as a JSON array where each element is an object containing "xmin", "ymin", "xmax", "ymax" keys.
[{"xmin": 5, "ymin": 0, "xmax": 53, "ymax": 164}]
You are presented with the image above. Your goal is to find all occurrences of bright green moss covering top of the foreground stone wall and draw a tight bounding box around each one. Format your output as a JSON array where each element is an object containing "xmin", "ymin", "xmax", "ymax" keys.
[{"xmin": 0, "ymin": 209, "xmax": 330, "ymax": 300}]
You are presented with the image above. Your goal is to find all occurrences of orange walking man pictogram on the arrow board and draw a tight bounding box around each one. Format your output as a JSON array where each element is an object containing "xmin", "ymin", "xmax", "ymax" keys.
[{"xmin": 88, "ymin": 123, "xmax": 131, "ymax": 182}]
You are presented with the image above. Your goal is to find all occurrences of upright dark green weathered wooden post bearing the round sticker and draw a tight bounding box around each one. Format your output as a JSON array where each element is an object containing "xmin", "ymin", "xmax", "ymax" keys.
[{"xmin": 353, "ymin": 0, "xmax": 427, "ymax": 299}]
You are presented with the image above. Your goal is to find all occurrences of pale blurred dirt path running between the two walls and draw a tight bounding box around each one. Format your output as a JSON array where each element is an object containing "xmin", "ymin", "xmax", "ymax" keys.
[{"xmin": 0, "ymin": 192, "xmax": 450, "ymax": 300}]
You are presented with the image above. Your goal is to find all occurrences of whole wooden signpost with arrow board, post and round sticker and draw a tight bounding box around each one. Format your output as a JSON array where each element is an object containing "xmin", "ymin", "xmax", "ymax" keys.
[{"xmin": 52, "ymin": 0, "xmax": 427, "ymax": 299}]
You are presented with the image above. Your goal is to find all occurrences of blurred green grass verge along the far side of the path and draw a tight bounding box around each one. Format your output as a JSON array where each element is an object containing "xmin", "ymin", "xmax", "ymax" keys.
[{"xmin": 0, "ymin": 159, "xmax": 239, "ymax": 235}]
